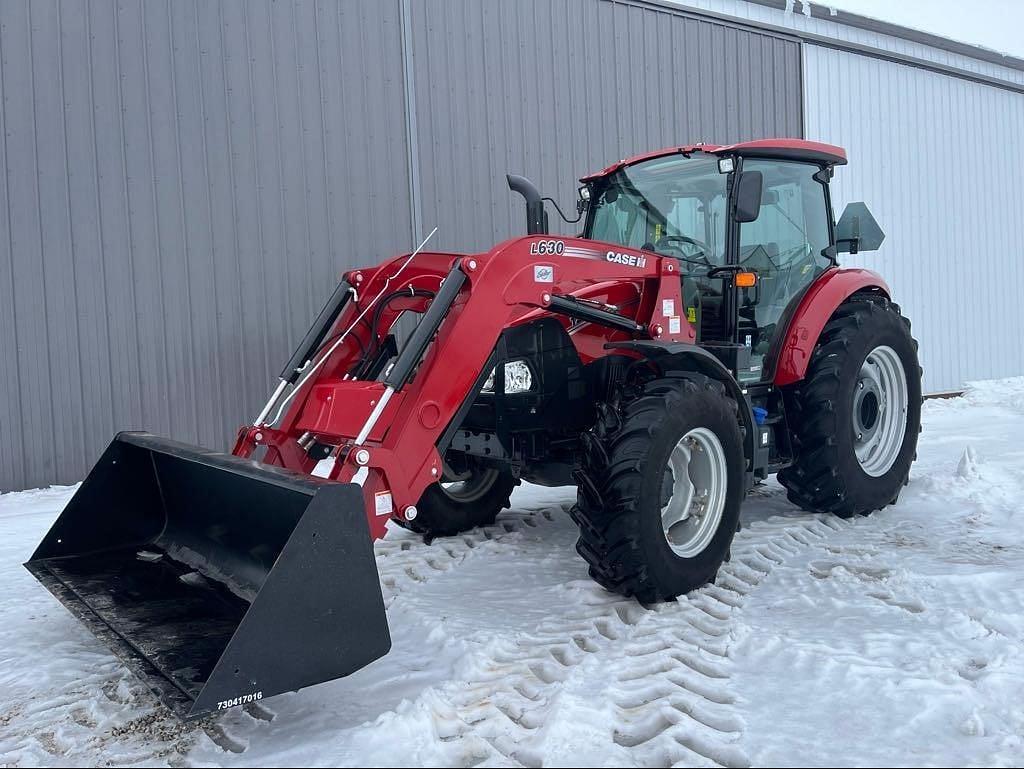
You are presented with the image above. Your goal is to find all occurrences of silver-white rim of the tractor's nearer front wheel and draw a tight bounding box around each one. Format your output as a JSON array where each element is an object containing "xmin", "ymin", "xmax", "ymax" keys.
[{"xmin": 662, "ymin": 427, "xmax": 729, "ymax": 558}]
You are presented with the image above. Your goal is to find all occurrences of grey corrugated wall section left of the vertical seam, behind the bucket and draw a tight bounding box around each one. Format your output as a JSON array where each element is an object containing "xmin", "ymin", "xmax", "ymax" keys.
[{"xmin": 0, "ymin": 0, "xmax": 412, "ymax": 489}]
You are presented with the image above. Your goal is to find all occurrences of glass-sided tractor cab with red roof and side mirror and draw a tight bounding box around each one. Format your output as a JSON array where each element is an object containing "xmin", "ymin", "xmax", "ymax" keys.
[{"xmin": 581, "ymin": 139, "xmax": 881, "ymax": 383}]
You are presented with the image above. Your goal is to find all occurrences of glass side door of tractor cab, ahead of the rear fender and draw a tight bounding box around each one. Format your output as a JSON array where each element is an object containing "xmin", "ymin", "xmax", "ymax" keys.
[{"xmin": 735, "ymin": 158, "xmax": 834, "ymax": 382}]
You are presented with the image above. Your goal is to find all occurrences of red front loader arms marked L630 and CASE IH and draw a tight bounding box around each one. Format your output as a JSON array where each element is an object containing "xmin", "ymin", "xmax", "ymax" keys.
[{"xmin": 234, "ymin": 237, "xmax": 695, "ymax": 538}]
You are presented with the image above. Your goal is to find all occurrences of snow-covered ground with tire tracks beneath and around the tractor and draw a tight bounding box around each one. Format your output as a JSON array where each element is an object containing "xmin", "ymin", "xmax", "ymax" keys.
[{"xmin": 0, "ymin": 379, "xmax": 1024, "ymax": 766}]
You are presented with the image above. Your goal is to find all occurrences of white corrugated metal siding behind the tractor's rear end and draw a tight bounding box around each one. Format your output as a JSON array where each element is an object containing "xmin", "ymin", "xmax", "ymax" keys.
[{"xmin": 804, "ymin": 45, "xmax": 1024, "ymax": 391}]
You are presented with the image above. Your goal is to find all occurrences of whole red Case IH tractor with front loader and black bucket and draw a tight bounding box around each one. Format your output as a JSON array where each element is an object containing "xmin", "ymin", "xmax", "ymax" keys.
[{"xmin": 27, "ymin": 139, "xmax": 921, "ymax": 717}]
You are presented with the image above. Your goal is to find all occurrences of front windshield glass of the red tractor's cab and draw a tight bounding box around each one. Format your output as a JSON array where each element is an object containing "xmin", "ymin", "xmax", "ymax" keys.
[{"xmin": 584, "ymin": 154, "xmax": 726, "ymax": 268}]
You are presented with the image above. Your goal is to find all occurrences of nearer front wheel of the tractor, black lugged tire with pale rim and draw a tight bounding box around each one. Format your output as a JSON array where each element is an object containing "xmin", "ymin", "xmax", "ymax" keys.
[{"xmin": 572, "ymin": 373, "xmax": 744, "ymax": 603}]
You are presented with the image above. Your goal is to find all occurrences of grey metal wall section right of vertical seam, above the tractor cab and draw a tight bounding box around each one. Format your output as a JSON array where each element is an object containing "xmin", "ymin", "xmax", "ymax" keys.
[{"xmin": 411, "ymin": 0, "xmax": 802, "ymax": 250}]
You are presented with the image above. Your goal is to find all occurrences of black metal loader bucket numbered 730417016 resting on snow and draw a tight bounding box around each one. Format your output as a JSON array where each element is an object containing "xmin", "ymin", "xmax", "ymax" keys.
[{"xmin": 25, "ymin": 433, "xmax": 391, "ymax": 719}]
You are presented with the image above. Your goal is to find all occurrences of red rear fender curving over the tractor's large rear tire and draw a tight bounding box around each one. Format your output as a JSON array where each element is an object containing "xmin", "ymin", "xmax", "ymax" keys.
[{"xmin": 768, "ymin": 267, "xmax": 889, "ymax": 387}]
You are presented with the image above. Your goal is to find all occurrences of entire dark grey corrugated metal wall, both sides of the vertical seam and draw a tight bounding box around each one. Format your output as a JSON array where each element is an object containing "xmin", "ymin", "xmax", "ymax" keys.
[{"xmin": 0, "ymin": 0, "xmax": 802, "ymax": 490}]
